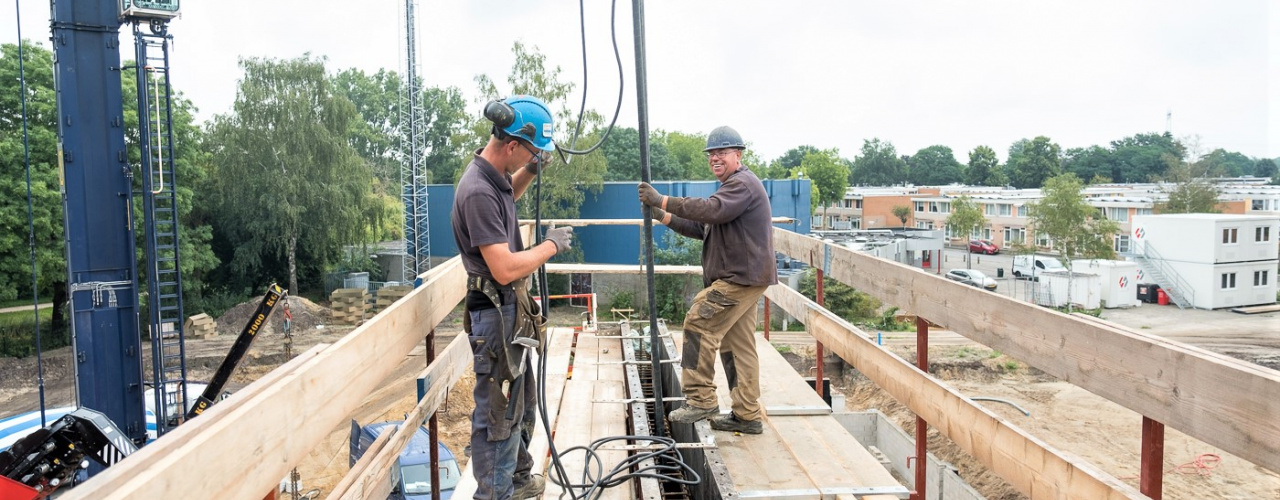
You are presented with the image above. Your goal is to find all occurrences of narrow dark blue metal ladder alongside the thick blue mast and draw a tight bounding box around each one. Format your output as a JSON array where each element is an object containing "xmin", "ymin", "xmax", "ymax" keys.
[{"xmin": 133, "ymin": 23, "xmax": 187, "ymax": 437}]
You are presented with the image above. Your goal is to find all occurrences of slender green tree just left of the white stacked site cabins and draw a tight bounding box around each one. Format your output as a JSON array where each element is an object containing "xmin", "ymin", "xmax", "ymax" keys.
[{"xmin": 1028, "ymin": 174, "xmax": 1120, "ymax": 308}]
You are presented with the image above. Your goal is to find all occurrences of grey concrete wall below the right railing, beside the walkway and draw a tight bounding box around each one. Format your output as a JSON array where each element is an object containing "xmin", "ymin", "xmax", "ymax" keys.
[{"xmin": 832, "ymin": 409, "xmax": 984, "ymax": 500}]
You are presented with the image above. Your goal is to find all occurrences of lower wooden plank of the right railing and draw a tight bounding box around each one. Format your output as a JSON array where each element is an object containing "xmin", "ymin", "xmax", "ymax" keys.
[{"xmin": 765, "ymin": 285, "xmax": 1142, "ymax": 499}]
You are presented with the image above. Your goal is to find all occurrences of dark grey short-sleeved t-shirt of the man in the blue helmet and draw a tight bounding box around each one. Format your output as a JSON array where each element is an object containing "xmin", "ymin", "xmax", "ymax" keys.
[{"xmin": 451, "ymin": 151, "xmax": 525, "ymax": 279}]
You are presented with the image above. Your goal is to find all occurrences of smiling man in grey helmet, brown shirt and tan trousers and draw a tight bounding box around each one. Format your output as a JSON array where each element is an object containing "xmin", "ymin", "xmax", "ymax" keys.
[{"xmin": 639, "ymin": 127, "xmax": 778, "ymax": 434}]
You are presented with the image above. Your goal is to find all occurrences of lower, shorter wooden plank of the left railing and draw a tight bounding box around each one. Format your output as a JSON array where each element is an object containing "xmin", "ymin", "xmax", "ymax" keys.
[{"xmin": 329, "ymin": 335, "xmax": 471, "ymax": 500}]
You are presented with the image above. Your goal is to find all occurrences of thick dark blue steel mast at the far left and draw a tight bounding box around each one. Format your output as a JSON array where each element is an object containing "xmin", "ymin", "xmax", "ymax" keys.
[{"xmin": 50, "ymin": 0, "xmax": 180, "ymax": 444}]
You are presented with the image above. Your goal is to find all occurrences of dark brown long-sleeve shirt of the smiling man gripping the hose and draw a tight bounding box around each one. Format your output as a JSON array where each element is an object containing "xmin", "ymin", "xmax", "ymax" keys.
[{"xmin": 667, "ymin": 166, "xmax": 778, "ymax": 286}]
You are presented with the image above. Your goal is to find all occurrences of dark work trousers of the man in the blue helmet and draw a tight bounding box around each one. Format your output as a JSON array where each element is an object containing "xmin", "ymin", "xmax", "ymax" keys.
[{"xmin": 467, "ymin": 304, "xmax": 538, "ymax": 500}]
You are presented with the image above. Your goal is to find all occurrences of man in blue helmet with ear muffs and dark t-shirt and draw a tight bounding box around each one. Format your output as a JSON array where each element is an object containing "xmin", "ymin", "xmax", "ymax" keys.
[{"xmin": 451, "ymin": 96, "xmax": 572, "ymax": 500}]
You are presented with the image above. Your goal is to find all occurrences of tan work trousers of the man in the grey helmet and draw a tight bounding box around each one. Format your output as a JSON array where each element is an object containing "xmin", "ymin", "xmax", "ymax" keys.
[{"xmin": 680, "ymin": 280, "xmax": 768, "ymax": 421}]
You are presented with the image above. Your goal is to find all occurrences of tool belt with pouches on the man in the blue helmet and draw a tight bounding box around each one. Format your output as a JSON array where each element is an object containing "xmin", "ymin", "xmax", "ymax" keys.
[{"xmin": 462, "ymin": 275, "xmax": 547, "ymax": 381}]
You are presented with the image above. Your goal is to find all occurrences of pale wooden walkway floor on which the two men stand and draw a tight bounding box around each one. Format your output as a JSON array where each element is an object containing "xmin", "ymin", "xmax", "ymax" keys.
[{"xmin": 453, "ymin": 329, "xmax": 908, "ymax": 500}]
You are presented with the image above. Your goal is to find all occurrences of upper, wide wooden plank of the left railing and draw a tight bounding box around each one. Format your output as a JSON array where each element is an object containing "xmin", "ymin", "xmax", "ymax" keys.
[{"xmin": 64, "ymin": 258, "xmax": 466, "ymax": 500}]
